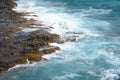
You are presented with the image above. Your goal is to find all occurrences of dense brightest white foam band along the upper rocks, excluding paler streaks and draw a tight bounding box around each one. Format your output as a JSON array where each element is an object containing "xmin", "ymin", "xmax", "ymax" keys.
[{"xmin": 14, "ymin": 0, "xmax": 82, "ymax": 35}]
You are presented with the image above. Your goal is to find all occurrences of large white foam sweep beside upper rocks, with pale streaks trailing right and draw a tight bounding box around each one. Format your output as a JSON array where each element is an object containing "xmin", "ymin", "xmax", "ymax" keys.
[{"xmin": 15, "ymin": 0, "xmax": 110, "ymax": 40}]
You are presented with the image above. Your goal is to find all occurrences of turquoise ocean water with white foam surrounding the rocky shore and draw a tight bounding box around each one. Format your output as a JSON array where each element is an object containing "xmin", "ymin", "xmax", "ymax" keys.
[{"xmin": 0, "ymin": 0, "xmax": 120, "ymax": 80}]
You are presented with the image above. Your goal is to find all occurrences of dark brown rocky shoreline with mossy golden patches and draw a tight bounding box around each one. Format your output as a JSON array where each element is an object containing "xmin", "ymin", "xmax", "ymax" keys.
[{"xmin": 0, "ymin": 0, "xmax": 59, "ymax": 72}]
